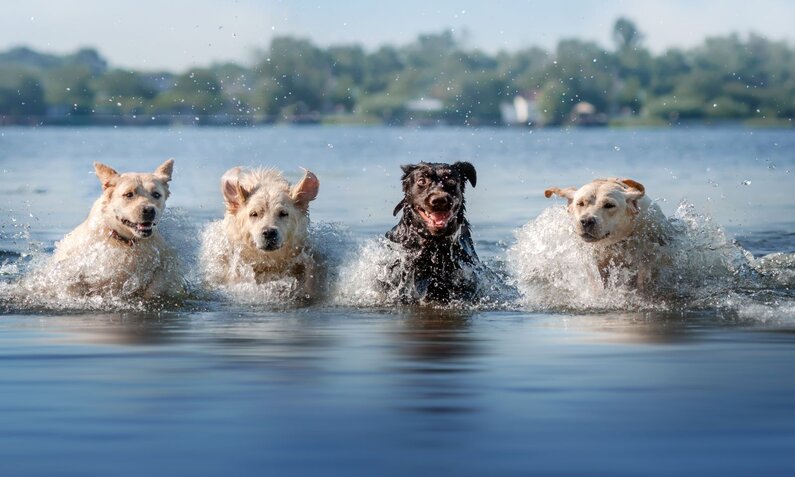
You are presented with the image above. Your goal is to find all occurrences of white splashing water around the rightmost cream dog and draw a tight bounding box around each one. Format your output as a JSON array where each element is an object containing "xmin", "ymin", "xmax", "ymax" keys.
[{"xmin": 508, "ymin": 202, "xmax": 795, "ymax": 314}]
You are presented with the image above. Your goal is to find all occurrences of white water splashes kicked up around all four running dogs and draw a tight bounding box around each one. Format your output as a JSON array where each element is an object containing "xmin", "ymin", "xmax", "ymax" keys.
[{"xmin": 0, "ymin": 202, "xmax": 795, "ymax": 320}]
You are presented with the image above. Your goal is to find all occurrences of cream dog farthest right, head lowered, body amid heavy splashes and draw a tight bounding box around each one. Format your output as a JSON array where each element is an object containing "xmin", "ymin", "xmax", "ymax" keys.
[{"xmin": 544, "ymin": 179, "xmax": 670, "ymax": 289}]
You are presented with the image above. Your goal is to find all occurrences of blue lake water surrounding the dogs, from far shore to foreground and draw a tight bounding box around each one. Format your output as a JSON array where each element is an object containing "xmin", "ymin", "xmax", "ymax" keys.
[{"xmin": 0, "ymin": 127, "xmax": 795, "ymax": 476}]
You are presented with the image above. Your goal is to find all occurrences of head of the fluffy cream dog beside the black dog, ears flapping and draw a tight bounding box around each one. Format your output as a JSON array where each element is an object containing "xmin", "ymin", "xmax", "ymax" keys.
[{"xmin": 221, "ymin": 167, "xmax": 320, "ymax": 251}]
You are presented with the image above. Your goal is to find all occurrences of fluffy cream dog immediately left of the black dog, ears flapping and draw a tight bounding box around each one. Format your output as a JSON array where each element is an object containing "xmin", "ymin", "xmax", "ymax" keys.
[{"xmin": 202, "ymin": 167, "xmax": 320, "ymax": 292}]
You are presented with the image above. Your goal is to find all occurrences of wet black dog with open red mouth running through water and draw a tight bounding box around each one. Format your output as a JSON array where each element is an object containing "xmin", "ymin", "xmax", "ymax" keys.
[{"xmin": 383, "ymin": 162, "xmax": 481, "ymax": 303}]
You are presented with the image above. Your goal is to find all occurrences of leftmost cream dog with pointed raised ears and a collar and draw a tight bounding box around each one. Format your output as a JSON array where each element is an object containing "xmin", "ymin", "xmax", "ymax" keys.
[{"xmin": 53, "ymin": 159, "xmax": 183, "ymax": 298}]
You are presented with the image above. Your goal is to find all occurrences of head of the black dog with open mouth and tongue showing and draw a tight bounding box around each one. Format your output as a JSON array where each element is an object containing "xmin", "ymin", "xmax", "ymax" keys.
[{"xmin": 393, "ymin": 162, "xmax": 477, "ymax": 235}]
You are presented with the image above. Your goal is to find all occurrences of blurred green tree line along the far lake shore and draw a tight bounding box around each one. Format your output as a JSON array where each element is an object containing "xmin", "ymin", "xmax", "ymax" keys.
[{"xmin": 0, "ymin": 18, "xmax": 795, "ymax": 125}]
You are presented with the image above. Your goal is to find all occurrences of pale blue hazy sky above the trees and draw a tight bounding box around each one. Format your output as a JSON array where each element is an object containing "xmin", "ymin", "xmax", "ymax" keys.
[{"xmin": 0, "ymin": 0, "xmax": 795, "ymax": 71}]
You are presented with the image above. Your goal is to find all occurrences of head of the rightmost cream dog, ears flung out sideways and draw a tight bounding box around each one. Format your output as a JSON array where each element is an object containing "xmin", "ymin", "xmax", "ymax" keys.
[{"xmin": 544, "ymin": 179, "xmax": 646, "ymax": 245}]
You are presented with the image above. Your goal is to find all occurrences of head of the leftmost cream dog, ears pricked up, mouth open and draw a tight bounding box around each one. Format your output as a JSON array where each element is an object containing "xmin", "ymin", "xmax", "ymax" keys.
[{"xmin": 94, "ymin": 159, "xmax": 174, "ymax": 240}]
